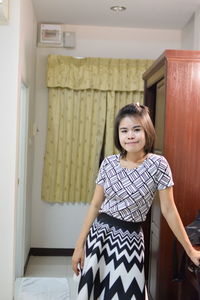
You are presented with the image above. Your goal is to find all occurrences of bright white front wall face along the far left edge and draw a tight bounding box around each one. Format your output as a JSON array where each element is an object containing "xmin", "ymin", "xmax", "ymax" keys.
[{"xmin": 0, "ymin": 0, "xmax": 20, "ymax": 300}]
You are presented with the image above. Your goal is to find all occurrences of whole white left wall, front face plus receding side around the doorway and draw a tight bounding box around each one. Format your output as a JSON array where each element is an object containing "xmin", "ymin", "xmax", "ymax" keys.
[{"xmin": 0, "ymin": 0, "xmax": 36, "ymax": 300}]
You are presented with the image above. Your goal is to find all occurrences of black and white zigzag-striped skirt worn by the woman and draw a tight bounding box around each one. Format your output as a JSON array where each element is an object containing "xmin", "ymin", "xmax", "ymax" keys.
[{"xmin": 77, "ymin": 213, "xmax": 145, "ymax": 300}]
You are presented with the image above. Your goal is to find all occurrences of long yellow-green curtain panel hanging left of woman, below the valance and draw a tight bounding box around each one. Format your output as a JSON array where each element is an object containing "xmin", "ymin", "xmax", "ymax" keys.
[{"xmin": 42, "ymin": 88, "xmax": 106, "ymax": 202}]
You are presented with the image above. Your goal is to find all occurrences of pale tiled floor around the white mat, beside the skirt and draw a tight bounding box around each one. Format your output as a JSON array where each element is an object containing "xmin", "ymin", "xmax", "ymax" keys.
[{"xmin": 25, "ymin": 256, "xmax": 78, "ymax": 300}]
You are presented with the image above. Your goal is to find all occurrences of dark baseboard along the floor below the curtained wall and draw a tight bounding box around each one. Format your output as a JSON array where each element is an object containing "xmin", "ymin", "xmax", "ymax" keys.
[{"xmin": 24, "ymin": 248, "xmax": 74, "ymax": 274}]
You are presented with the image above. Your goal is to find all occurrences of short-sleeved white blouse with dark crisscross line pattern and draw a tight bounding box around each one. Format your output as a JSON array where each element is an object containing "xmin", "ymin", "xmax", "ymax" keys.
[{"xmin": 96, "ymin": 154, "xmax": 174, "ymax": 222}]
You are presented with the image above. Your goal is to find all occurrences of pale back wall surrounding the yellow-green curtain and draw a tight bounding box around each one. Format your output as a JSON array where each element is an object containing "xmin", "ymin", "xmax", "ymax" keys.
[{"xmin": 31, "ymin": 25, "xmax": 181, "ymax": 248}]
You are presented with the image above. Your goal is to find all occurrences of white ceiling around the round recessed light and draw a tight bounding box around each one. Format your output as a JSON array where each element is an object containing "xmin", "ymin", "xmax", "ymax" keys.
[{"xmin": 32, "ymin": 0, "xmax": 200, "ymax": 29}]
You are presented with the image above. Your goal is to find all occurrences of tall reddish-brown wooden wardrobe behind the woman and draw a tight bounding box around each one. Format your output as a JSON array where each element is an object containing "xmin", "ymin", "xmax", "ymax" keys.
[{"xmin": 143, "ymin": 50, "xmax": 200, "ymax": 300}]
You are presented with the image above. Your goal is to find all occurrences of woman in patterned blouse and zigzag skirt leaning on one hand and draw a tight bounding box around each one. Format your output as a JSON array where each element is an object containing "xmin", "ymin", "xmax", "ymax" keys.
[{"xmin": 72, "ymin": 104, "xmax": 200, "ymax": 300}]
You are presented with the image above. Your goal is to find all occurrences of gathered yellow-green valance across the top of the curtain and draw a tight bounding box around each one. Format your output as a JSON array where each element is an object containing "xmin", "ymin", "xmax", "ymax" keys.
[{"xmin": 47, "ymin": 55, "xmax": 153, "ymax": 92}]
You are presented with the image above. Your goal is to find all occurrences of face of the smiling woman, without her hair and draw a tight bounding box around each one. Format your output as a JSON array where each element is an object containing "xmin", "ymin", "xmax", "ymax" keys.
[{"xmin": 119, "ymin": 116, "xmax": 146, "ymax": 153}]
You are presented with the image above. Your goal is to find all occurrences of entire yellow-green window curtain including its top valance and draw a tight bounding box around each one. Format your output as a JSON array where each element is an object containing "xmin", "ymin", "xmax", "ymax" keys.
[{"xmin": 42, "ymin": 55, "xmax": 152, "ymax": 203}]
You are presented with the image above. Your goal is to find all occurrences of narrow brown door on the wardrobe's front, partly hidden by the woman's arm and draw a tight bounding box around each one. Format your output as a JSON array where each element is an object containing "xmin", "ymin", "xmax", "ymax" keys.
[{"xmin": 148, "ymin": 79, "xmax": 165, "ymax": 300}]
